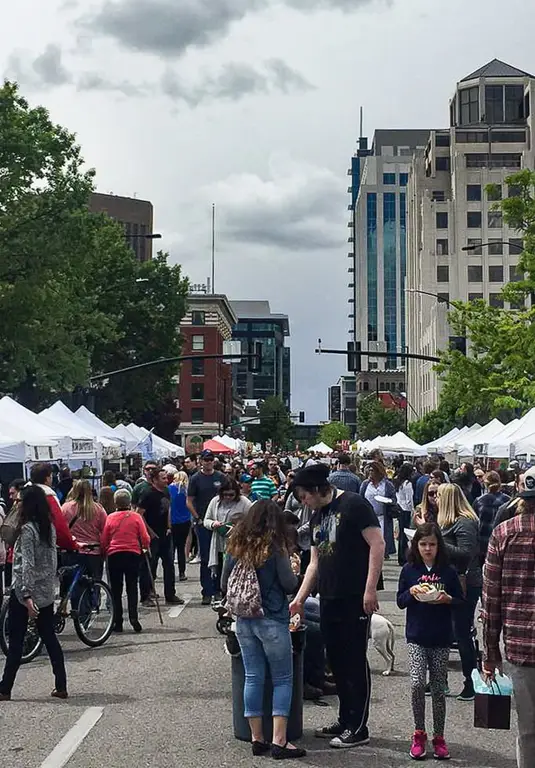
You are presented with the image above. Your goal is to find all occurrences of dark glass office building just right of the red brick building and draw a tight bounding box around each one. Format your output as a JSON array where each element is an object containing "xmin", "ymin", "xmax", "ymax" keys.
[{"xmin": 231, "ymin": 301, "xmax": 290, "ymax": 408}]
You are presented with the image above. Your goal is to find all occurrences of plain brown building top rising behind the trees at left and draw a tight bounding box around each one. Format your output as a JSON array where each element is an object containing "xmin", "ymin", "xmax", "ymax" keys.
[{"xmin": 89, "ymin": 192, "xmax": 153, "ymax": 261}]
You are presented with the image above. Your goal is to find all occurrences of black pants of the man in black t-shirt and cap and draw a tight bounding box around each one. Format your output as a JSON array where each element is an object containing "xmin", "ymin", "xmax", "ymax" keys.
[{"xmin": 321, "ymin": 597, "xmax": 371, "ymax": 731}]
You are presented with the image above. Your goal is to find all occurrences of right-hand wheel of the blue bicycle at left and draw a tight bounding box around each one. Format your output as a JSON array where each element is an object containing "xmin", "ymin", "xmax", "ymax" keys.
[{"xmin": 72, "ymin": 579, "xmax": 115, "ymax": 648}]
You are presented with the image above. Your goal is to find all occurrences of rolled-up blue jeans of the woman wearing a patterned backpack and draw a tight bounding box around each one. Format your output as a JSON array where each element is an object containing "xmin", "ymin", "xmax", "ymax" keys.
[{"xmin": 236, "ymin": 618, "xmax": 293, "ymax": 717}]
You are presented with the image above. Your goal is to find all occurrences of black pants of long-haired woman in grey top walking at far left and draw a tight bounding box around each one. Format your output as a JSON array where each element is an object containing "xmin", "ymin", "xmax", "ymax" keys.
[{"xmin": 0, "ymin": 592, "xmax": 67, "ymax": 694}]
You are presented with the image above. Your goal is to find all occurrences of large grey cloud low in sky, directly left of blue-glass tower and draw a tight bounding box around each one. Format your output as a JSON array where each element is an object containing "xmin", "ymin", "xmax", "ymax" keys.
[{"xmin": 207, "ymin": 158, "xmax": 345, "ymax": 252}]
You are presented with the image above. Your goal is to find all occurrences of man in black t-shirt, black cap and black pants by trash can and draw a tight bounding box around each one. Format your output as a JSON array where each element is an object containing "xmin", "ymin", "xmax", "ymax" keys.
[{"xmin": 290, "ymin": 464, "xmax": 385, "ymax": 749}]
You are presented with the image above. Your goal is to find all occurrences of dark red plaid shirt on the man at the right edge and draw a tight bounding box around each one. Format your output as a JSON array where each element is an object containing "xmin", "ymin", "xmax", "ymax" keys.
[{"xmin": 482, "ymin": 512, "xmax": 535, "ymax": 666}]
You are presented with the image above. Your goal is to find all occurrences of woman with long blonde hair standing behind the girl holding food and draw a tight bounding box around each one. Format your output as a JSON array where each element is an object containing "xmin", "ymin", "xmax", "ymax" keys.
[{"xmin": 437, "ymin": 483, "xmax": 483, "ymax": 701}]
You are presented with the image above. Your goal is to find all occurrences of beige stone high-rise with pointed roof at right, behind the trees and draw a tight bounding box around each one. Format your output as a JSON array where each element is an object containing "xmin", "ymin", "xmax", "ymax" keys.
[{"xmin": 406, "ymin": 59, "xmax": 535, "ymax": 420}]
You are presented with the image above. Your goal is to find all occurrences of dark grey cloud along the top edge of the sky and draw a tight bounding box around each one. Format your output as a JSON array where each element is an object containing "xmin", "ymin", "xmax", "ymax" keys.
[{"xmin": 79, "ymin": 0, "xmax": 392, "ymax": 59}]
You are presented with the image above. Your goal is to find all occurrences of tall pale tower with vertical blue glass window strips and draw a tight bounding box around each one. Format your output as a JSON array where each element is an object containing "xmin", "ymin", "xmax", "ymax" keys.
[{"xmin": 349, "ymin": 130, "xmax": 429, "ymax": 380}]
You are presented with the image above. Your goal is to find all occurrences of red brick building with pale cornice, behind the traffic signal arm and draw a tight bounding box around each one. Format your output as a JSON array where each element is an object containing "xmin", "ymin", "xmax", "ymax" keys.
[{"xmin": 176, "ymin": 293, "xmax": 237, "ymax": 452}]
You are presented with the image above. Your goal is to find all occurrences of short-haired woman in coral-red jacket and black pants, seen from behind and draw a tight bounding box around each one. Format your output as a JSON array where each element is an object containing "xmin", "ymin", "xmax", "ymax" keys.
[{"xmin": 100, "ymin": 489, "xmax": 150, "ymax": 632}]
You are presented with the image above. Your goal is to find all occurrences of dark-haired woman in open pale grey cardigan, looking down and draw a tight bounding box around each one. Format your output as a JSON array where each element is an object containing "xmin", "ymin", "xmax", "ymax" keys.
[{"xmin": 203, "ymin": 477, "xmax": 251, "ymax": 602}]
